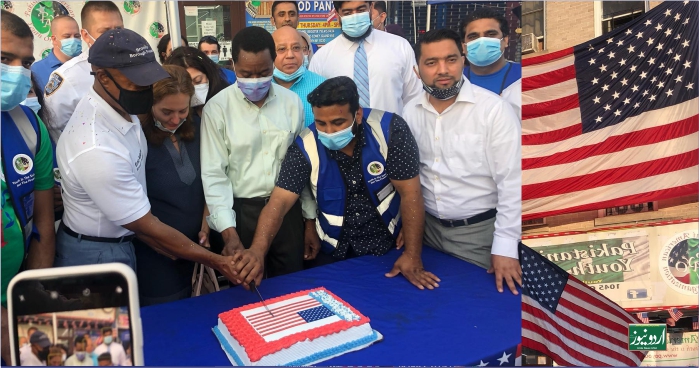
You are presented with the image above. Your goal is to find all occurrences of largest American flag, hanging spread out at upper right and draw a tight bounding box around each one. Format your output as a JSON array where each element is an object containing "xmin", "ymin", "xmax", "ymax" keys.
[{"xmin": 522, "ymin": 1, "xmax": 699, "ymax": 220}]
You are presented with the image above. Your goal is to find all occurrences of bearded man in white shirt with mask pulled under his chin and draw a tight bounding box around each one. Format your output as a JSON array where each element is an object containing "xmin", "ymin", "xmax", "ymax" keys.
[{"xmin": 405, "ymin": 29, "xmax": 522, "ymax": 295}]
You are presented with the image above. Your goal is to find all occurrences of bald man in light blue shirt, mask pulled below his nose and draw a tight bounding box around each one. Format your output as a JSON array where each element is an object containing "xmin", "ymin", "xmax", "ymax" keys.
[{"xmin": 272, "ymin": 26, "xmax": 325, "ymax": 126}]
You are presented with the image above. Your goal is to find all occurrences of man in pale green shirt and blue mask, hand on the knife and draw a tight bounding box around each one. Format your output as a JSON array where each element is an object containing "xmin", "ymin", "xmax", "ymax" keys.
[{"xmin": 201, "ymin": 27, "xmax": 320, "ymax": 288}]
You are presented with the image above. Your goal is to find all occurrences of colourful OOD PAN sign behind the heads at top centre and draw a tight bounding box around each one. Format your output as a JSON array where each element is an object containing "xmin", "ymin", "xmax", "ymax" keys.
[{"xmin": 245, "ymin": 1, "xmax": 342, "ymax": 45}]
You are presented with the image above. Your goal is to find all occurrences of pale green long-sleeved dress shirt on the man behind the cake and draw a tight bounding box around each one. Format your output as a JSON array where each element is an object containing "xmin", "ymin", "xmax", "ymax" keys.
[{"xmin": 201, "ymin": 83, "xmax": 317, "ymax": 232}]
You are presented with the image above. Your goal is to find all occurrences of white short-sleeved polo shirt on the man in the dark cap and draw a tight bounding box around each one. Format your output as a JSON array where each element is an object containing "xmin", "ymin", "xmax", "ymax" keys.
[{"xmin": 56, "ymin": 87, "xmax": 150, "ymax": 238}]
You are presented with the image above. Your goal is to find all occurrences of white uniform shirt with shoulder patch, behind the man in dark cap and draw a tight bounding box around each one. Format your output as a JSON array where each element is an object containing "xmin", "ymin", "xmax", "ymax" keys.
[{"xmin": 44, "ymin": 48, "xmax": 95, "ymax": 142}]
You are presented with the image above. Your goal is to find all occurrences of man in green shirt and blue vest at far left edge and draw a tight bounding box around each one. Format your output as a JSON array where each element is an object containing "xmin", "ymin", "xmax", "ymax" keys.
[{"xmin": 0, "ymin": 10, "xmax": 54, "ymax": 363}]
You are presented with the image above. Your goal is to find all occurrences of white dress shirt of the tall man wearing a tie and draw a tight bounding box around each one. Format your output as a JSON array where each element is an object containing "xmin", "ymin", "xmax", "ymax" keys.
[{"xmin": 309, "ymin": 30, "xmax": 422, "ymax": 116}]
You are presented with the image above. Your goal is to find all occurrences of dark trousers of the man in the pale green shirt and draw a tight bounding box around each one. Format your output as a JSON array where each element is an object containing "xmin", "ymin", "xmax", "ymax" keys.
[{"xmin": 233, "ymin": 198, "xmax": 304, "ymax": 277}]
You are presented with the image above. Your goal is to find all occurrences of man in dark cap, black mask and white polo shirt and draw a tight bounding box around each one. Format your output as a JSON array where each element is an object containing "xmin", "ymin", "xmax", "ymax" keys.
[{"xmin": 54, "ymin": 29, "xmax": 241, "ymax": 279}]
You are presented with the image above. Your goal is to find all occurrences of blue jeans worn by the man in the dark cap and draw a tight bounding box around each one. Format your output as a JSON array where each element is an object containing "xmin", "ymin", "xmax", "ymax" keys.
[{"xmin": 53, "ymin": 229, "xmax": 136, "ymax": 271}]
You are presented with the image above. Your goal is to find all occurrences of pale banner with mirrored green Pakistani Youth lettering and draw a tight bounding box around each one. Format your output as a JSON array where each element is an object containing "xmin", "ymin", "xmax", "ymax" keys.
[{"xmin": 523, "ymin": 222, "xmax": 699, "ymax": 309}]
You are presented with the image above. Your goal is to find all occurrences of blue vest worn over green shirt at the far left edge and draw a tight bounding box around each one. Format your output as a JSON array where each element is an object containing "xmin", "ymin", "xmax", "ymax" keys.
[{"xmin": 2, "ymin": 105, "xmax": 41, "ymax": 248}]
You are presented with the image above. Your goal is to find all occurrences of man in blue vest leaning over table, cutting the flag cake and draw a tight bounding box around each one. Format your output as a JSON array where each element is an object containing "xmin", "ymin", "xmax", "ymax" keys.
[{"xmin": 228, "ymin": 77, "xmax": 440, "ymax": 289}]
